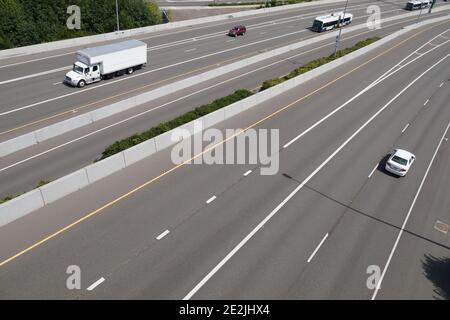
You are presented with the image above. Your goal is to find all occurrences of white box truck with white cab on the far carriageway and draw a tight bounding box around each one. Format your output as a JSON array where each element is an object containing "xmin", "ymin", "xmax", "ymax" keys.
[{"xmin": 64, "ymin": 40, "xmax": 147, "ymax": 88}]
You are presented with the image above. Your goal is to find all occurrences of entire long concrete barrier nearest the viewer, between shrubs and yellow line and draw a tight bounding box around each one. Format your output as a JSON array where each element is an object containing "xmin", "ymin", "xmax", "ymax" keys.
[{"xmin": 0, "ymin": 17, "xmax": 449, "ymax": 227}]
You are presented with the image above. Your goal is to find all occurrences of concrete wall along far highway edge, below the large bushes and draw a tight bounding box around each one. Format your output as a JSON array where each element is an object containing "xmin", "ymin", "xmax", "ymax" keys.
[{"xmin": 0, "ymin": 0, "xmax": 344, "ymax": 59}]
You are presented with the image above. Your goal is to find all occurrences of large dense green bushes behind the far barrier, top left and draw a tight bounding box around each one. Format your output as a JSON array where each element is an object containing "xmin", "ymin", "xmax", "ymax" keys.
[{"xmin": 0, "ymin": 0, "xmax": 162, "ymax": 49}]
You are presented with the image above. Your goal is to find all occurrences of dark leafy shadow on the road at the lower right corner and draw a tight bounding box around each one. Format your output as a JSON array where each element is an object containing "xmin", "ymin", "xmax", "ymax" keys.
[{"xmin": 422, "ymin": 254, "xmax": 450, "ymax": 300}]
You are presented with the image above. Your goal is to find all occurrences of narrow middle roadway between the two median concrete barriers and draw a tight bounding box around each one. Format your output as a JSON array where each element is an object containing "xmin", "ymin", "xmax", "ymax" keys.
[{"xmin": 0, "ymin": 3, "xmax": 446, "ymax": 197}]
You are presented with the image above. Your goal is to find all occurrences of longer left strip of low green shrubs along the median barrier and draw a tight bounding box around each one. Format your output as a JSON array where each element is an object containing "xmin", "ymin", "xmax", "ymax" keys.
[{"xmin": 96, "ymin": 90, "xmax": 252, "ymax": 161}]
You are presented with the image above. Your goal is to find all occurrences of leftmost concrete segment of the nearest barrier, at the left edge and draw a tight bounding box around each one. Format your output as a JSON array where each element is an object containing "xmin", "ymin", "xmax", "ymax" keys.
[{"xmin": 0, "ymin": 189, "xmax": 44, "ymax": 227}]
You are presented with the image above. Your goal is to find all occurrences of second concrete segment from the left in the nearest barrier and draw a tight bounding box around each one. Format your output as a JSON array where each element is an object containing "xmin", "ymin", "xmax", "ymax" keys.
[{"xmin": 39, "ymin": 169, "xmax": 89, "ymax": 204}]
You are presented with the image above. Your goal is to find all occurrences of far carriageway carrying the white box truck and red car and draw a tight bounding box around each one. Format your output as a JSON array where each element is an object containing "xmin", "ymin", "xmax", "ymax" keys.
[{"xmin": 0, "ymin": 1, "xmax": 436, "ymax": 141}]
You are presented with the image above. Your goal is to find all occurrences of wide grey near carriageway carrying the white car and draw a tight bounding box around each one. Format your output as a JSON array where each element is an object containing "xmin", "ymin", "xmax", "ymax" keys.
[{"xmin": 0, "ymin": 17, "xmax": 450, "ymax": 299}]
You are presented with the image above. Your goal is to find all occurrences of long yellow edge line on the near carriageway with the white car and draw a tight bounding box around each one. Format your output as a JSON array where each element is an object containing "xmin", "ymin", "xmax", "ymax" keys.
[{"xmin": 0, "ymin": 21, "xmax": 446, "ymax": 267}]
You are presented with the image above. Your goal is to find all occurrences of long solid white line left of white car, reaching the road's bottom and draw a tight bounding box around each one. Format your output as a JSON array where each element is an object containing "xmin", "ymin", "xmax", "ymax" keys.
[{"xmin": 183, "ymin": 54, "xmax": 450, "ymax": 300}]
